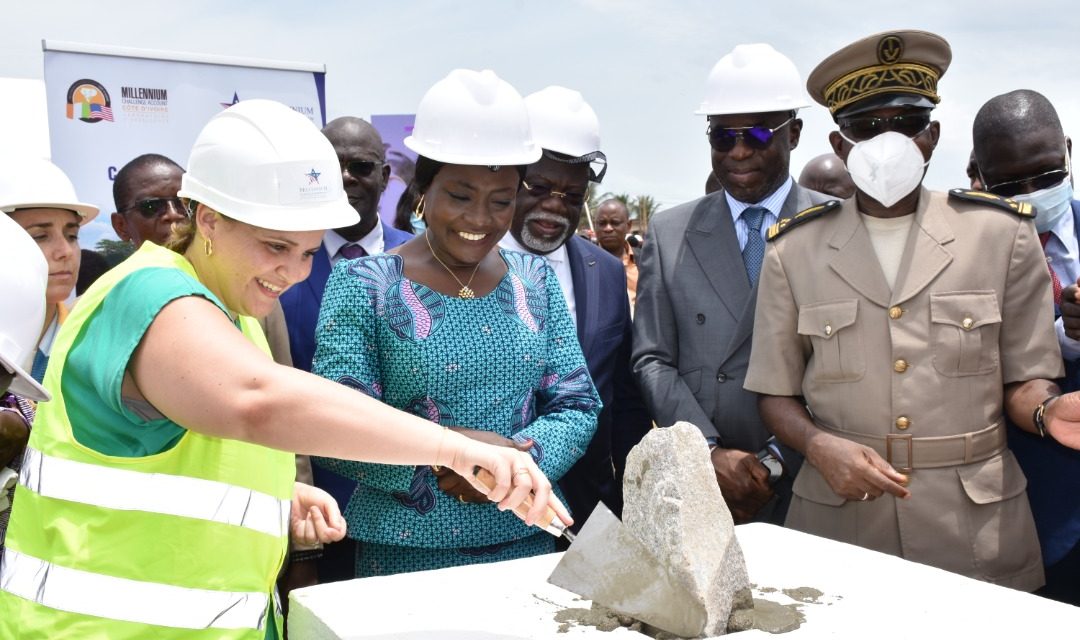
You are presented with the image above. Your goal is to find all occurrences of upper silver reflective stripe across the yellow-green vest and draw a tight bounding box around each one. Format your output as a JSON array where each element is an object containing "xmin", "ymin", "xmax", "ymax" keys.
[{"xmin": 18, "ymin": 447, "xmax": 292, "ymax": 537}]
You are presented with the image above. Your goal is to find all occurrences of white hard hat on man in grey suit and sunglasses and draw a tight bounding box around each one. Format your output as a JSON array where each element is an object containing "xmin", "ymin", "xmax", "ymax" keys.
[{"xmin": 694, "ymin": 44, "xmax": 810, "ymax": 115}]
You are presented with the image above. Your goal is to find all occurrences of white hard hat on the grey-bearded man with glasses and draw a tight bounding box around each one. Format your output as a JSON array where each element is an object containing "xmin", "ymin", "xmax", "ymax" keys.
[{"xmin": 525, "ymin": 86, "xmax": 607, "ymax": 182}]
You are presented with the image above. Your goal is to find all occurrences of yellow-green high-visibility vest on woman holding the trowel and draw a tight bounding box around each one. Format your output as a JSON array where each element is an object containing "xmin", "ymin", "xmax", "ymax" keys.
[{"xmin": 0, "ymin": 241, "xmax": 295, "ymax": 640}]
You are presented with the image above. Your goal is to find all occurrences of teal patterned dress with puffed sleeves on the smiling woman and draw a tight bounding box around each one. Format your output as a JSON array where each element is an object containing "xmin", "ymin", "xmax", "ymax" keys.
[{"xmin": 312, "ymin": 251, "xmax": 600, "ymax": 576}]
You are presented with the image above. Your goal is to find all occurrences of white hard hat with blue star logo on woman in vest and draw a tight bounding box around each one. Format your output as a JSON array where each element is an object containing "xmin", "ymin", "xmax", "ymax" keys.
[{"xmin": 177, "ymin": 99, "xmax": 360, "ymax": 231}]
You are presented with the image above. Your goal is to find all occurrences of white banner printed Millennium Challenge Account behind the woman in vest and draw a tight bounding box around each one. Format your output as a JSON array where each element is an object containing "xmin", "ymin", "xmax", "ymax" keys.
[{"xmin": 42, "ymin": 41, "xmax": 326, "ymax": 248}]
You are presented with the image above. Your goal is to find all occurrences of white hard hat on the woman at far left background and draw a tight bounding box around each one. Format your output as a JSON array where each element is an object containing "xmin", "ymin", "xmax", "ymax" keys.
[{"xmin": 0, "ymin": 156, "xmax": 98, "ymax": 223}]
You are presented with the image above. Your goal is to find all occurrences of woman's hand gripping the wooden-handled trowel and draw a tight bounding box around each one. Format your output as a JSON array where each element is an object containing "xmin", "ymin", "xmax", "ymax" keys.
[{"xmin": 445, "ymin": 430, "xmax": 573, "ymax": 526}]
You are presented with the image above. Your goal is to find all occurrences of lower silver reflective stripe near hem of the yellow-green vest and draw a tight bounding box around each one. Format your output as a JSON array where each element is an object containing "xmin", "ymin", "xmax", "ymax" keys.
[{"xmin": 0, "ymin": 549, "xmax": 269, "ymax": 629}]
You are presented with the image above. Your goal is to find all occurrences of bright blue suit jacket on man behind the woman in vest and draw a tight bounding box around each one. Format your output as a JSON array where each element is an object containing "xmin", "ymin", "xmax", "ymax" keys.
[{"xmin": 281, "ymin": 222, "xmax": 413, "ymax": 371}]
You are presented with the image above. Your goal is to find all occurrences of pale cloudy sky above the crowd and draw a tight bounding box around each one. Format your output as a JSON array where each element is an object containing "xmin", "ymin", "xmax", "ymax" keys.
[{"xmin": 0, "ymin": 0, "xmax": 1080, "ymax": 246}]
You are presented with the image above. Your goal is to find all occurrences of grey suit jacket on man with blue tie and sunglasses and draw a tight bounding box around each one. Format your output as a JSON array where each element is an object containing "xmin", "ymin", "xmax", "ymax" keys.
[{"xmin": 632, "ymin": 185, "xmax": 831, "ymax": 451}]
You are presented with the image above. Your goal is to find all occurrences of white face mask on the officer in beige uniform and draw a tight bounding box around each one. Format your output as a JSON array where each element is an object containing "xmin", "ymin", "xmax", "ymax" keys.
[{"xmin": 840, "ymin": 131, "xmax": 930, "ymax": 207}]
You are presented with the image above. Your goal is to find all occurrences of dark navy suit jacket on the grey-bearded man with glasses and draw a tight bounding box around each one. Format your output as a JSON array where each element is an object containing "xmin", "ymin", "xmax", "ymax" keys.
[{"xmin": 558, "ymin": 235, "xmax": 651, "ymax": 529}]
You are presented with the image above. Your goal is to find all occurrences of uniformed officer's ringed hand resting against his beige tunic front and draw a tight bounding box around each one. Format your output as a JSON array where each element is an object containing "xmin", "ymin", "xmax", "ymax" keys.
[{"xmin": 807, "ymin": 432, "xmax": 912, "ymax": 500}]
